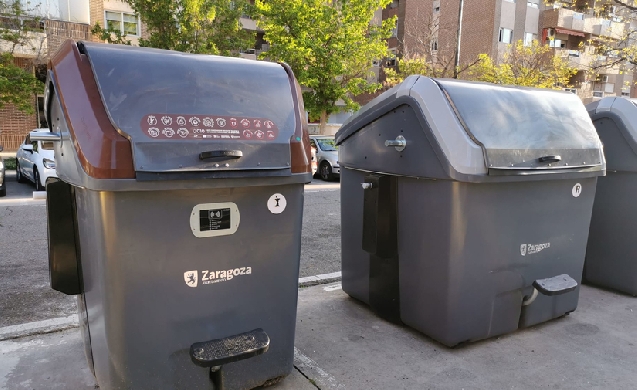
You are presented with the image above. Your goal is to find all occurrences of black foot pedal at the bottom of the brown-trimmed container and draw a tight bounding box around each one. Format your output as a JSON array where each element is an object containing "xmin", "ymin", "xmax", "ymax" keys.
[{"xmin": 190, "ymin": 328, "xmax": 270, "ymax": 367}]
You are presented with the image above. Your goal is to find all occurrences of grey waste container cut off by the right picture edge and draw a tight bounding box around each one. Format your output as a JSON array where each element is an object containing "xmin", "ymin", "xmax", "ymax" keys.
[{"xmin": 584, "ymin": 97, "xmax": 637, "ymax": 296}]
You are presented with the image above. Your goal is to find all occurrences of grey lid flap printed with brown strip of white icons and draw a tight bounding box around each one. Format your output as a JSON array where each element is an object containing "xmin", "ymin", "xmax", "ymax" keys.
[{"xmin": 81, "ymin": 42, "xmax": 298, "ymax": 177}]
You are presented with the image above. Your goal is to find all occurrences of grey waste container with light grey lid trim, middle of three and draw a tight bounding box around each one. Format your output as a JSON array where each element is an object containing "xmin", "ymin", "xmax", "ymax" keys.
[{"xmin": 336, "ymin": 76, "xmax": 605, "ymax": 346}]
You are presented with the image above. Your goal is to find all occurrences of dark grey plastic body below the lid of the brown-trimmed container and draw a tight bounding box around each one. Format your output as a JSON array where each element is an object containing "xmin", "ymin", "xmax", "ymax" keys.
[{"xmin": 76, "ymin": 184, "xmax": 303, "ymax": 389}]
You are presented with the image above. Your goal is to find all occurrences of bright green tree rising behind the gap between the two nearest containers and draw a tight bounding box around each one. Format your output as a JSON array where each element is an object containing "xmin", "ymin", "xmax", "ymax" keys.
[{"xmin": 256, "ymin": 0, "xmax": 396, "ymax": 130}]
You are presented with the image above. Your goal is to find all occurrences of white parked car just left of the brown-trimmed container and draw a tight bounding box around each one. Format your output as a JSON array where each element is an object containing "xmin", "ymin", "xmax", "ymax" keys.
[{"xmin": 15, "ymin": 129, "xmax": 57, "ymax": 191}]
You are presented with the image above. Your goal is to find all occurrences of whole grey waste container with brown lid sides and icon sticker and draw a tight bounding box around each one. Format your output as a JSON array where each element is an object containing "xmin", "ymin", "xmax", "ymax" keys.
[{"xmin": 40, "ymin": 41, "xmax": 311, "ymax": 390}]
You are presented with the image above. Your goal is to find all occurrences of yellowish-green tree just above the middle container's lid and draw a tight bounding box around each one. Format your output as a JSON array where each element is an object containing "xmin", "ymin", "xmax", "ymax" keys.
[{"xmin": 469, "ymin": 41, "xmax": 577, "ymax": 89}]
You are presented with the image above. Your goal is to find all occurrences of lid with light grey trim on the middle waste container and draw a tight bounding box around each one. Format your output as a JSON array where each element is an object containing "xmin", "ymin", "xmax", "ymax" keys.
[{"xmin": 336, "ymin": 75, "xmax": 605, "ymax": 175}]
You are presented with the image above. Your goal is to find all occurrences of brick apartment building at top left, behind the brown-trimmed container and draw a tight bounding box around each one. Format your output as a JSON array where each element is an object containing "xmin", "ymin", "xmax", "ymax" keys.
[{"xmin": 0, "ymin": 0, "xmax": 145, "ymax": 151}]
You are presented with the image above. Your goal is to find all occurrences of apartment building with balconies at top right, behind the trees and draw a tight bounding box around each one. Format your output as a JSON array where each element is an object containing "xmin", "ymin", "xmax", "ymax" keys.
[{"xmin": 383, "ymin": 0, "xmax": 637, "ymax": 103}]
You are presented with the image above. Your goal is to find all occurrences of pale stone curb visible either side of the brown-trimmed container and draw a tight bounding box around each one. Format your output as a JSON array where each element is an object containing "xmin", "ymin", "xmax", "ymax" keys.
[{"xmin": 0, "ymin": 271, "xmax": 341, "ymax": 341}]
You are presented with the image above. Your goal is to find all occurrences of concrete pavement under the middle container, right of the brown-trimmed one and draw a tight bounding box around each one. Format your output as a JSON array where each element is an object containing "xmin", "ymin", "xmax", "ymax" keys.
[{"xmin": 295, "ymin": 284, "xmax": 637, "ymax": 390}]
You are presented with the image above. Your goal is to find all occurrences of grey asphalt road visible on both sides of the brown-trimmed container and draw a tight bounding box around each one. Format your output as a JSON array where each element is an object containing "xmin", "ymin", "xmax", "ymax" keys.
[{"xmin": 0, "ymin": 171, "xmax": 341, "ymax": 328}]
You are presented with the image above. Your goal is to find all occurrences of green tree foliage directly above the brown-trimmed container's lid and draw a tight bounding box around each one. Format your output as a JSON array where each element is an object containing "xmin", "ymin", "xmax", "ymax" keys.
[{"xmin": 125, "ymin": 0, "xmax": 256, "ymax": 56}]
